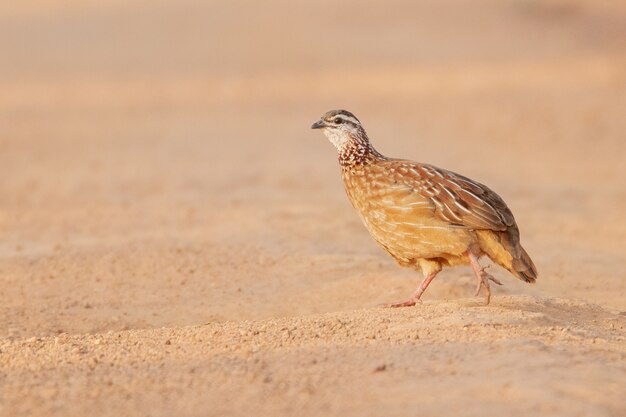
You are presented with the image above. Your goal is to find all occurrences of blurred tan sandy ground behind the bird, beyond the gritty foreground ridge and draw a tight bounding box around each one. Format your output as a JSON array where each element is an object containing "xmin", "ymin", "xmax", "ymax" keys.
[{"xmin": 0, "ymin": 0, "xmax": 626, "ymax": 337}]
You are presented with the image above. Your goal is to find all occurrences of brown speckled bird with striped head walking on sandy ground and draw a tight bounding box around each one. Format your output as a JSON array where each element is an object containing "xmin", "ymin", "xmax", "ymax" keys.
[{"xmin": 311, "ymin": 110, "xmax": 537, "ymax": 307}]
